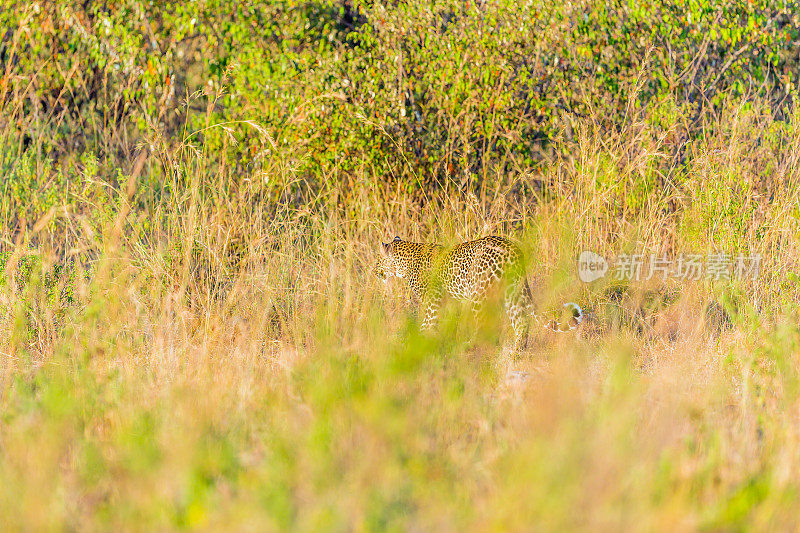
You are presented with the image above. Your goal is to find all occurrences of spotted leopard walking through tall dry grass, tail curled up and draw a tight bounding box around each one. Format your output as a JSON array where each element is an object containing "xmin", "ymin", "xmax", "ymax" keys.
[{"xmin": 373, "ymin": 235, "xmax": 584, "ymax": 352}]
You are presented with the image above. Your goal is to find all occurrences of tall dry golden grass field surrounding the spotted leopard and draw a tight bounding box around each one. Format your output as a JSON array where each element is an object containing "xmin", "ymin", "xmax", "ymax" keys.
[{"xmin": 0, "ymin": 74, "xmax": 800, "ymax": 530}]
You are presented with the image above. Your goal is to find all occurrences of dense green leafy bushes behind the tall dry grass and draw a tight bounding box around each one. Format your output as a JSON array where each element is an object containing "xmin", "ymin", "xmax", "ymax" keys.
[{"xmin": 6, "ymin": 0, "xmax": 800, "ymax": 202}]
